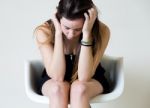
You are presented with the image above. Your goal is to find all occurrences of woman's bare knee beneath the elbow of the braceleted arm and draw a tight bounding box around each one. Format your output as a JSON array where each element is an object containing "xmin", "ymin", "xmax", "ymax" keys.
[{"xmin": 71, "ymin": 81, "xmax": 87, "ymax": 97}]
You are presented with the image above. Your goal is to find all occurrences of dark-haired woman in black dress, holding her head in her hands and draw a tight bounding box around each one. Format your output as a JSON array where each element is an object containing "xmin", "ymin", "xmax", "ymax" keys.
[{"xmin": 35, "ymin": 0, "xmax": 110, "ymax": 108}]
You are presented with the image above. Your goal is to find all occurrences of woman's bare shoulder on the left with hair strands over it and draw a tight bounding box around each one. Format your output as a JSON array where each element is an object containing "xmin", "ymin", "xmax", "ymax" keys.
[{"xmin": 34, "ymin": 19, "xmax": 53, "ymax": 45}]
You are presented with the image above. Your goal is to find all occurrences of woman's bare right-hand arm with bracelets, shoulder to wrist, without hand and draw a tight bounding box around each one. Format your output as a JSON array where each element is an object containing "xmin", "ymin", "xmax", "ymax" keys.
[{"xmin": 78, "ymin": 24, "xmax": 110, "ymax": 81}]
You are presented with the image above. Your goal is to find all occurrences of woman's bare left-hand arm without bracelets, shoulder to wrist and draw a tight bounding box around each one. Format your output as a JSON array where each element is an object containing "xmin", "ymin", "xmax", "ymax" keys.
[{"xmin": 36, "ymin": 22, "xmax": 65, "ymax": 81}]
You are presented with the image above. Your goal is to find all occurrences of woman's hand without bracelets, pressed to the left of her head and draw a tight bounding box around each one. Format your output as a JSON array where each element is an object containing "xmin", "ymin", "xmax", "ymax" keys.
[{"xmin": 52, "ymin": 9, "xmax": 62, "ymax": 35}]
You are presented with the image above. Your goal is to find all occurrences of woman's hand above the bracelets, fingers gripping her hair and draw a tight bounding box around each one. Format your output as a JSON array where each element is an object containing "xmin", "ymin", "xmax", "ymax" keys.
[{"xmin": 82, "ymin": 7, "xmax": 97, "ymax": 38}]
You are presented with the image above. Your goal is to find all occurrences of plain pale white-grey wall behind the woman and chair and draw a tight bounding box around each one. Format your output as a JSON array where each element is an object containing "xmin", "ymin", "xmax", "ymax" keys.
[{"xmin": 0, "ymin": 0, "xmax": 150, "ymax": 108}]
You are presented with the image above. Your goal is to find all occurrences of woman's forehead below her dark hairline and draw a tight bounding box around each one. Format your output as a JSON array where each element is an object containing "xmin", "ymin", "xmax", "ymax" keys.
[{"xmin": 60, "ymin": 17, "xmax": 84, "ymax": 29}]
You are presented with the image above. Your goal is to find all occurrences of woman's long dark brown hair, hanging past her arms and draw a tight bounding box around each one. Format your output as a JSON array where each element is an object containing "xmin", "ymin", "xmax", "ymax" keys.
[{"xmin": 34, "ymin": 0, "xmax": 102, "ymax": 82}]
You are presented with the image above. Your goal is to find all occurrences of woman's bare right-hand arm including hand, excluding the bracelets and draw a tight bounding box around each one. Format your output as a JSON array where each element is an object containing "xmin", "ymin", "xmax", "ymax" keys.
[{"xmin": 78, "ymin": 9, "xmax": 110, "ymax": 81}]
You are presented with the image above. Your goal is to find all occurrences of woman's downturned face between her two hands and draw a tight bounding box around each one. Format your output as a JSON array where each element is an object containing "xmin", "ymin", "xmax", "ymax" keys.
[{"xmin": 60, "ymin": 17, "xmax": 84, "ymax": 40}]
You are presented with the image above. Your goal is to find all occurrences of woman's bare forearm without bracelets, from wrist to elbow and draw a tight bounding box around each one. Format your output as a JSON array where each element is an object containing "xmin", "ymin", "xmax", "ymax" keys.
[{"xmin": 51, "ymin": 34, "xmax": 66, "ymax": 81}]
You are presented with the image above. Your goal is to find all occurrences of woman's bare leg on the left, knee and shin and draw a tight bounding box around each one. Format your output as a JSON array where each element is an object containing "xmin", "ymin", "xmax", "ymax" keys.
[{"xmin": 42, "ymin": 79, "xmax": 70, "ymax": 108}]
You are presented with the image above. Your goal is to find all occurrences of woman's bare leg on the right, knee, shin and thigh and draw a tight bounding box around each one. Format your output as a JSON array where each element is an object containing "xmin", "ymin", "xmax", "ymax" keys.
[{"xmin": 70, "ymin": 79, "xmax": 103, "ymax": 108}]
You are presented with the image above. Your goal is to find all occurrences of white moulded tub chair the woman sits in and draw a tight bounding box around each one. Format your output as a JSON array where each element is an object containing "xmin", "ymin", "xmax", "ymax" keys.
[{"xmin": 25, "ymin": 55, "xmax": 124, "ymax": 104}]
